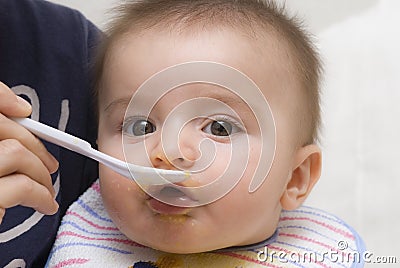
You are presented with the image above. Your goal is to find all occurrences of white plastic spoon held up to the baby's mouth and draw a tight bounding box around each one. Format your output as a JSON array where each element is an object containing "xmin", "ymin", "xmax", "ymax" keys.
[{"xmin": 11, "ymin": 118, "xmax": 190, "ymax": 185}]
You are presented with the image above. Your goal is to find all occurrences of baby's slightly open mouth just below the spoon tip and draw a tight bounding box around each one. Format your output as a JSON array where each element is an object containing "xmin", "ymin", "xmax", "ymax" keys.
[{"xmin": 146, "ymin": 184, "xmax": 198, "ymax": 215}]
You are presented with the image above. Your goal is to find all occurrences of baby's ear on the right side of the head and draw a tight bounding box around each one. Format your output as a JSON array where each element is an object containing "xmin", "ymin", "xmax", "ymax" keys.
[{"xmin": 281, "ymin": 144, "xmax": 322, "ymax": 210}]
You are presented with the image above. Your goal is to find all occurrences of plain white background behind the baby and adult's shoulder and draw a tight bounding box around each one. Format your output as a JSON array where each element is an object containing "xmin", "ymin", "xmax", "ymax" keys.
[{"xmin": 48, "ymin": 0, "xmax": 400, "ymax": 267}]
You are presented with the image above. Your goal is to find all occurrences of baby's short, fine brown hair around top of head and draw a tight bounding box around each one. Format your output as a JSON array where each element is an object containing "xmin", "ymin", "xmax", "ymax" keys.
[{"xmin": 94, "ymin": 0, "xmax": 322, "ymax": 145}]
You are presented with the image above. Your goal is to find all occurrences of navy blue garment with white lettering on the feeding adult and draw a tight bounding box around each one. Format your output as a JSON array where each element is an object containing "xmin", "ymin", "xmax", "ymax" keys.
[{"xmin": 0, "ymin": 0, "xmax": 100, "ymax": 267}]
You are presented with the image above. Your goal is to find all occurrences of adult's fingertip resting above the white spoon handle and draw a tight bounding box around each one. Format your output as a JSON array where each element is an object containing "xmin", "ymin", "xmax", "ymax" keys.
[{"xmin": 0, "ymin": 82, "xmax": 32, "ymax": 117}]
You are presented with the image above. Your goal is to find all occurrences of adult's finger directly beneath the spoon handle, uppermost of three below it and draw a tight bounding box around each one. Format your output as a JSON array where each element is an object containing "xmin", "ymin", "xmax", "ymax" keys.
[{"xmin": 0, "ymin": 114, "xmax": 58, "ymax": 173}]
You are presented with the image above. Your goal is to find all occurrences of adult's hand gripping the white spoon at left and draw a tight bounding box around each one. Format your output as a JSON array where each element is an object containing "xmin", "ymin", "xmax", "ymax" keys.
[{"xmin": 0, "ymin": 82, "xmax": 58, "ymax": 224}]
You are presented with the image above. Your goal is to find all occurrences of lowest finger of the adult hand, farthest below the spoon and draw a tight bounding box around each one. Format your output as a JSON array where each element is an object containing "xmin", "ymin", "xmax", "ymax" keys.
[{"xmin": 0, "ymin": 174, "xmax": 58, "ymax": 215}]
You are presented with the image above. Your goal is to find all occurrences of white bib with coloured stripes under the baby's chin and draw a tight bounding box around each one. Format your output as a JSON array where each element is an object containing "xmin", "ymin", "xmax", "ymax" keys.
[{"xmin": 46, "ymin": 181, "xmax": 365, "ymax": 268}]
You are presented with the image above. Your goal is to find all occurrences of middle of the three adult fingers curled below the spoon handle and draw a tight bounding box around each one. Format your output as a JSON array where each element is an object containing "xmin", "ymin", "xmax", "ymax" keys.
[{"xmin": 0, "ymin": 140, "xmax": 55, "ymax": 195}]
